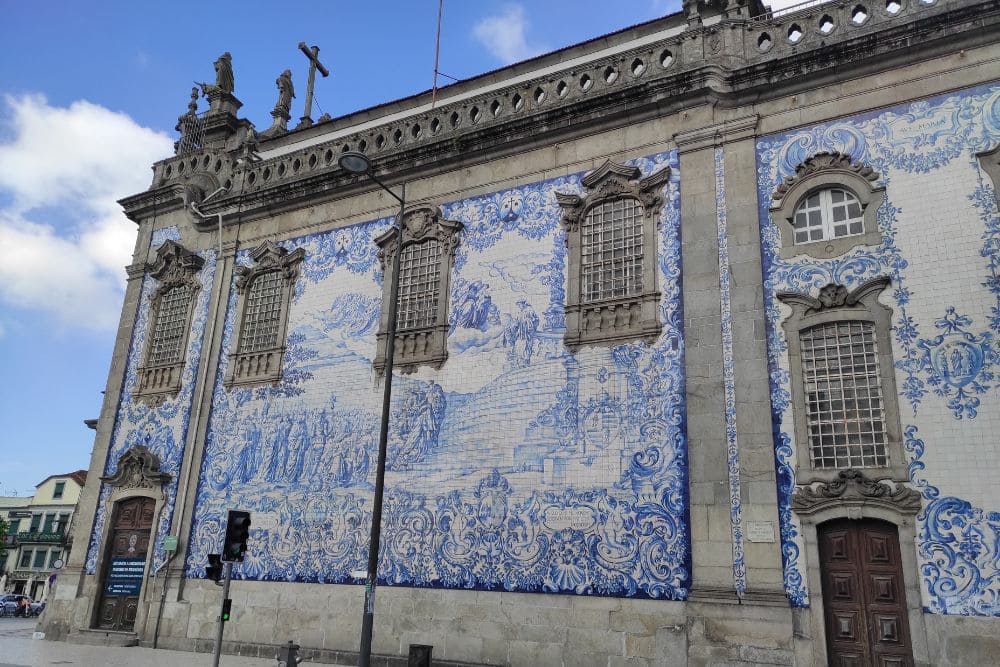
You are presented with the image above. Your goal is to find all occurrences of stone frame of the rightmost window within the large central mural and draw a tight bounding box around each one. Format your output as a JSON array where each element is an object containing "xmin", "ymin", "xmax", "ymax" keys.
[{"xmin": 556, "ymin": 160, "xmax": 670, "ymax": 352}]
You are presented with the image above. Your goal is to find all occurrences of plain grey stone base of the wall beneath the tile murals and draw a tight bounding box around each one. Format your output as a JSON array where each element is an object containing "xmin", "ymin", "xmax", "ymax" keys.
[{"xmin": 42, "ymin": 577, "xmax": 1000, "ymax": 667}]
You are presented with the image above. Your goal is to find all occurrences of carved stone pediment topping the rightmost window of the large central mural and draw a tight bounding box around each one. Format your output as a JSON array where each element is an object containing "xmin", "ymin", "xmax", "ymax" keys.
[{"xmin": 556, "ymin": 160, "xmax": 670, "ymax": 232}]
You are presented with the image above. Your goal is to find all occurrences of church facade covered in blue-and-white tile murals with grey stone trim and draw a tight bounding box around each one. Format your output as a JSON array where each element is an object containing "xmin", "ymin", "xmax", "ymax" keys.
[{"xmin": 43, "ymin": 0, "xmax": 1000, "ymax": 666}]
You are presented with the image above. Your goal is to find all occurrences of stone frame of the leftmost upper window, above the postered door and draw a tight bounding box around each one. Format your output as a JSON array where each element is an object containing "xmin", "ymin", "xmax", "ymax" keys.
[{"xmin": 133, "ymin": 241, "xmax": 205, "ymax": 405}]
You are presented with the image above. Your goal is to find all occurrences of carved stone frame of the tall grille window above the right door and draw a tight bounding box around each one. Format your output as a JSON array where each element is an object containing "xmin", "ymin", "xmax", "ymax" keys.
[{"xmin": 776, "ymin": 276, "xmax": 907, "ymax": 484}]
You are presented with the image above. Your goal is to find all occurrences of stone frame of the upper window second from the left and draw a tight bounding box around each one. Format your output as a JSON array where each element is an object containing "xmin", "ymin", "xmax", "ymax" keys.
[{"xmin": 224, "ymin": 241, "xmax": 306, "ymax": 389}]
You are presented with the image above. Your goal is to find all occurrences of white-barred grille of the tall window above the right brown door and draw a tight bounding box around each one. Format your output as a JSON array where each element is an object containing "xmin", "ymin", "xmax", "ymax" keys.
[{"xmin": 800, "ymin": 321, "xmax": 888, "ymax": 469}]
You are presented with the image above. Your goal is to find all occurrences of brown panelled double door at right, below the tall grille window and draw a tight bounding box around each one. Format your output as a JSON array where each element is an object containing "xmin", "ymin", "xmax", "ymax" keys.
[{"xmin": 818, "ymin": 519, "xmax": 913, "ymax": 667}]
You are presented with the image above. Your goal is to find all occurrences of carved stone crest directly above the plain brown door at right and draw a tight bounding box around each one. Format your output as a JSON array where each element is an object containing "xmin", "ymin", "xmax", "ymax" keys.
[{"xmin": 792, "ymin": 468, "xmax": 920, "ymax": 515}]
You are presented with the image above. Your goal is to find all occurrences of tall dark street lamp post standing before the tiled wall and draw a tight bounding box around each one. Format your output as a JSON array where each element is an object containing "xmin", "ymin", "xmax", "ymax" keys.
[{"xmin": 338, "ymin": 151, "xmax": 406, "ymax": 667}]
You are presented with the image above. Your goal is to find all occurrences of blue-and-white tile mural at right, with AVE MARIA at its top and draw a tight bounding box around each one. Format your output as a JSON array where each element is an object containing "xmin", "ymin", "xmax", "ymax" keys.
[{"xmin": 757, "ymin": 85, "xmax": 1000, "ymax": 616}]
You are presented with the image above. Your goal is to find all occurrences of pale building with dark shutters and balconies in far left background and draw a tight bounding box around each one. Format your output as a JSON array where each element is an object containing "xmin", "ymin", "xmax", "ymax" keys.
[{"xmin": 0, "ymin": 470, "xmax": 87, "ymax": 600}]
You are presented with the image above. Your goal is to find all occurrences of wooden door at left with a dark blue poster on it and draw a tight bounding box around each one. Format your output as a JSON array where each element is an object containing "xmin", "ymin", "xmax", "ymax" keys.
[{"xmin": 97, "ymin": 498, "xmax": 156, "ymax": 632}]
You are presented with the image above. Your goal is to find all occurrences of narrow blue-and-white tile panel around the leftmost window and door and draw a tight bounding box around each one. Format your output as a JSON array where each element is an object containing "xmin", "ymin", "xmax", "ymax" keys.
[{"xmin": 85, "ymin": 227, "xmax": 216, "ymax": 574}]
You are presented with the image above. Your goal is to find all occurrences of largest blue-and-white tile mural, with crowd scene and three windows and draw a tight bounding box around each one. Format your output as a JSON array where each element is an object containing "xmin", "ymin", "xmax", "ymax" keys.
[{"xmin": 186, "ymin": 152, "xmax": 690, "ymax": 599}]
